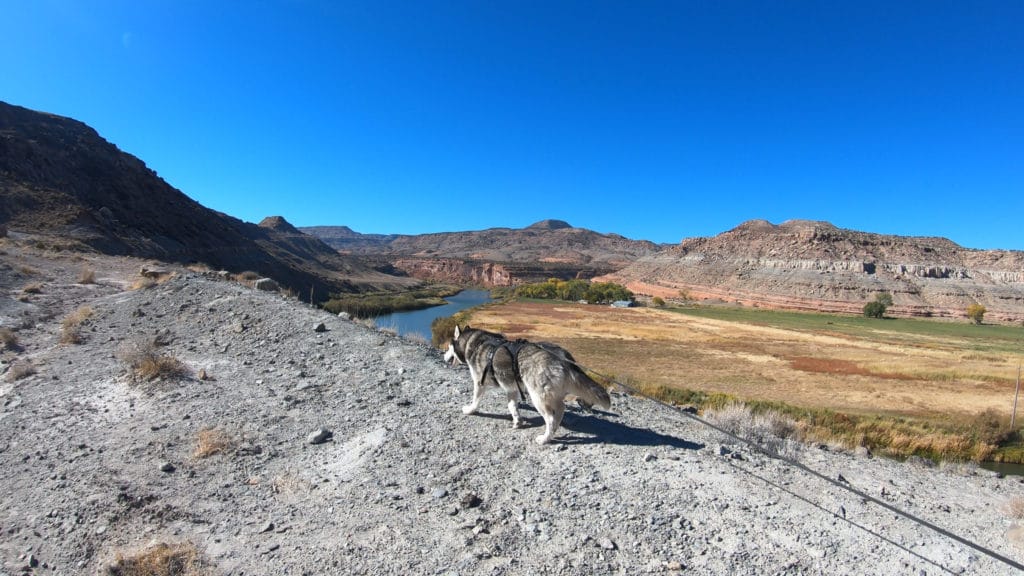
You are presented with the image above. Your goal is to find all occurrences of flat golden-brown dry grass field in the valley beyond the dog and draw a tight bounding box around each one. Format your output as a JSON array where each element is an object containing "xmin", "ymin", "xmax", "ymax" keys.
[{"xmin": 470, "ymin": 300, "xmax": 1024, "ymax": 457}]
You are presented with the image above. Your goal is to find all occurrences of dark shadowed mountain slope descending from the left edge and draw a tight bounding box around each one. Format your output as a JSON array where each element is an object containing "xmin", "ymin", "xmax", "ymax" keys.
[{"xmin": 0, "ymin": 102, "xmax": 413, "ymax": 298}]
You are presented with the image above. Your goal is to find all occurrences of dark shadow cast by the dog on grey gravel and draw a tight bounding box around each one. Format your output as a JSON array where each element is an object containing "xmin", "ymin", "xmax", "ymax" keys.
[{"xmin": 475, "ymin": 407, "xmax": 705, "ymax": 450}]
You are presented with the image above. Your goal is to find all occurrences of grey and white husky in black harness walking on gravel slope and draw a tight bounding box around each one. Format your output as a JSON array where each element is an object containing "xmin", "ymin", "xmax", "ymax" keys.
[{"xmin": 444, "ymin": 326, "xmax": 611, "ymax": 444}]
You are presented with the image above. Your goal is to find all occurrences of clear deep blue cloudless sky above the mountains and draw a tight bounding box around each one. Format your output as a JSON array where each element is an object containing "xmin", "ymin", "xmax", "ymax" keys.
[{"xmin": 0, "ymin": 0, "xmax": 1024, "ymax": 249}]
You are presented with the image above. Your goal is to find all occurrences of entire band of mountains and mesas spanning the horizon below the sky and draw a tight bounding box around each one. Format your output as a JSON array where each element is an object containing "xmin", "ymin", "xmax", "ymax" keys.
[{"xmin": 0, "ymin": 102, "xmax": 1024, "ymax": 323}]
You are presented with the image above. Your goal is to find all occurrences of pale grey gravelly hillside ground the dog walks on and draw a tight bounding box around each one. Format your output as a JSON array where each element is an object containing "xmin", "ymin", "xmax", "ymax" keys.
[{"xmin": 0, "ymin": 239, "xmax": 1024, "ymax": 575}]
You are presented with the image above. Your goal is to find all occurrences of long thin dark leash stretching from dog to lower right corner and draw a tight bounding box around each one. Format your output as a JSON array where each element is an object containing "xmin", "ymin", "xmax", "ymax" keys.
[{"xmin": 538, "ymin": 346, "xmax": 1024, "ymax": 572}]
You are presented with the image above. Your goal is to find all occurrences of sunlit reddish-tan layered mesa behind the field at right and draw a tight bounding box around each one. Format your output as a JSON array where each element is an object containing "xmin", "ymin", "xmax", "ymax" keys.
[{"xmin": 602, "ymin": 220, "xmax": 1024, "ymax": 323}]
